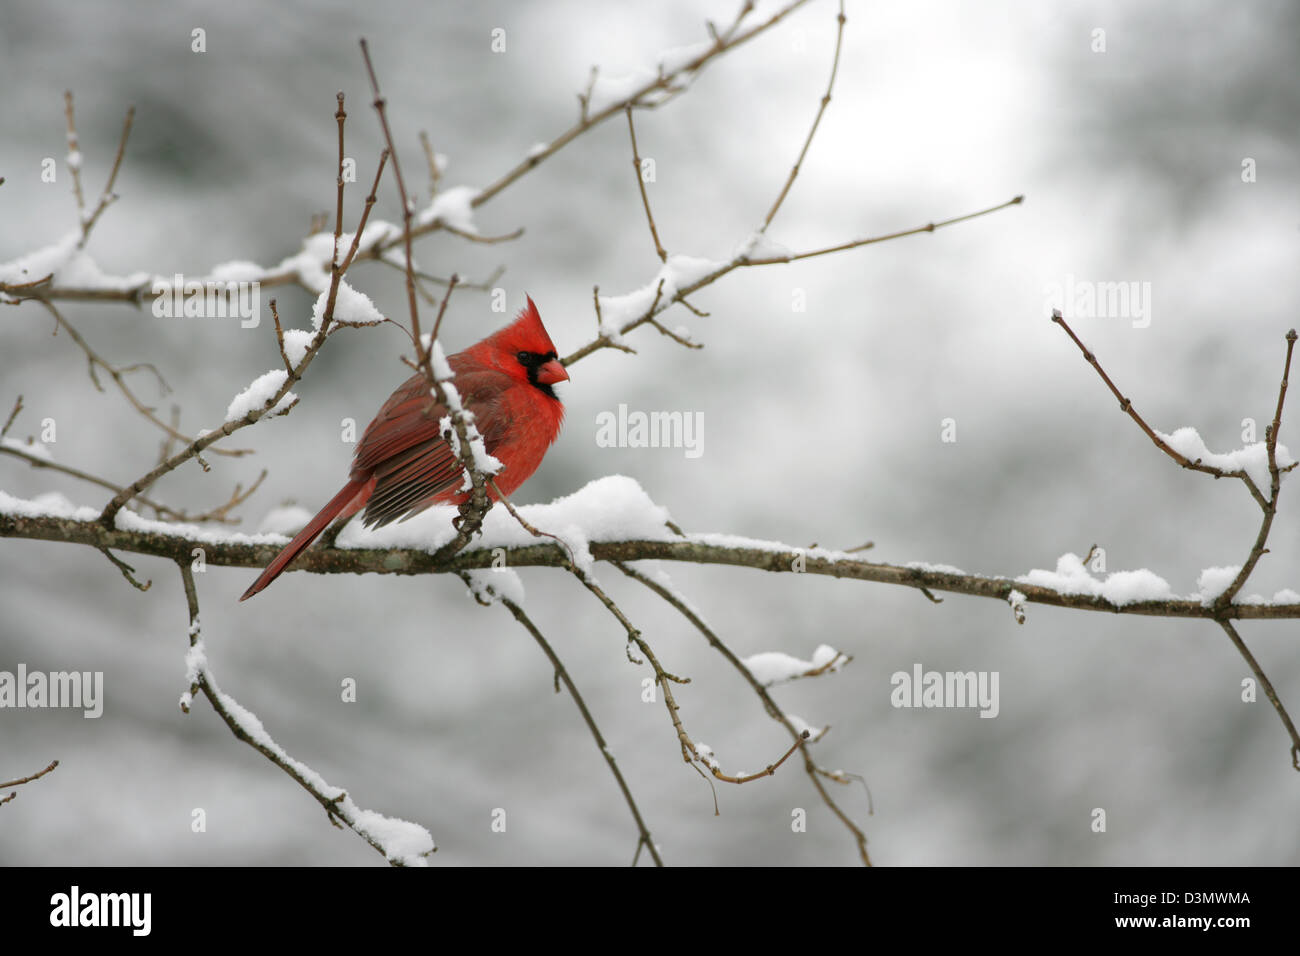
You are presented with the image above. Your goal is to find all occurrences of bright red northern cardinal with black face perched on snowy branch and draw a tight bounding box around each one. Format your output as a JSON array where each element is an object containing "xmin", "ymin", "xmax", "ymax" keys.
[{"xmin": 239, "ymin": 298, "xmax": 568, "ymax": 601}]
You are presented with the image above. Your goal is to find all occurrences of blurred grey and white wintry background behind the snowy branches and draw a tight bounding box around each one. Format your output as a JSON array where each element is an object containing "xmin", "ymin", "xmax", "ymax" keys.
[{"xmin": 0, "ymin": 0, "xmax": 1300, "ymax": 865}]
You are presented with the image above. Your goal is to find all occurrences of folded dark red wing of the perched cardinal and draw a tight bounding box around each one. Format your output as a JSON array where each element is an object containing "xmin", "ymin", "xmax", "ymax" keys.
[{"xmin": 352, "ymin": 369, "xmax": 512, "ymax": 527}]
